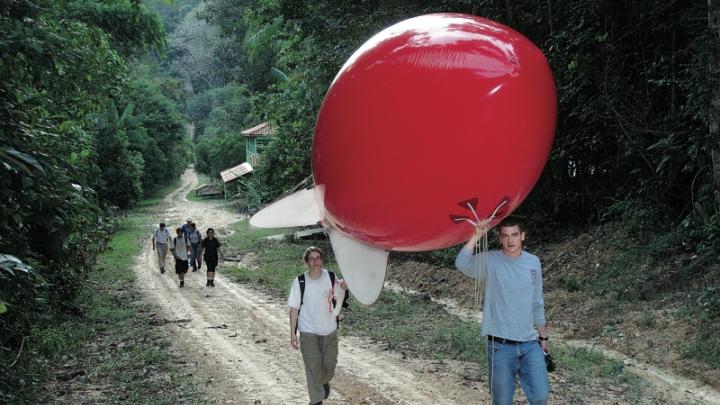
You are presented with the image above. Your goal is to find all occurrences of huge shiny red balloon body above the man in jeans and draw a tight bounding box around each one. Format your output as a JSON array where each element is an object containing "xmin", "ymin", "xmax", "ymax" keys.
[{"xmin": 312, "ymin": 14, "xmax": 557, "ymax": 251}]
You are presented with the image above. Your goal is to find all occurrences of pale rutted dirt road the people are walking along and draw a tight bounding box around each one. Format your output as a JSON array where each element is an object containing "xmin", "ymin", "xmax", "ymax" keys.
[{"xmin": 135, "ymin": 171, "xmax": 486, "ymax": 404}]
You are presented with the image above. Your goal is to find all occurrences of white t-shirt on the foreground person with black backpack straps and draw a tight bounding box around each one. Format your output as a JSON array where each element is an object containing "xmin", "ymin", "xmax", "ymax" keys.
[{"xmin": 288, "ymin": 269, "xmax": 340, "ymax": 336}]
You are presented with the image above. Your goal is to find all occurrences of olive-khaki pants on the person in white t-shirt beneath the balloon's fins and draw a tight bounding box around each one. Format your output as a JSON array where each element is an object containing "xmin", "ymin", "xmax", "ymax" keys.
[{"xmin": 300, "ymin": 331, "xmax": 338, "ymax": 404}]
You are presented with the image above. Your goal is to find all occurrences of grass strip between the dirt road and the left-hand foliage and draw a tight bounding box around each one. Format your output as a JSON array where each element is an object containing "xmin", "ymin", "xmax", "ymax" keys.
[{"xmin": 3, "ymin": 185, "xmax": 199, "ymax": 404}]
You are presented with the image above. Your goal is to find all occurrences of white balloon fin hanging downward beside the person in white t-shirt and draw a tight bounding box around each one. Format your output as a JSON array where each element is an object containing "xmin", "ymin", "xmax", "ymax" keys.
[{"xmin": 328, "ymin": 229, "xmax": 388, "ymax": 305}]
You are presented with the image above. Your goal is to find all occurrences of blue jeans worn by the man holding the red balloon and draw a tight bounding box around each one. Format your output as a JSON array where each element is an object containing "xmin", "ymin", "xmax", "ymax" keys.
[{"xmin": 487, "ymin": 340, "xmax": 550, "ymax": 405}]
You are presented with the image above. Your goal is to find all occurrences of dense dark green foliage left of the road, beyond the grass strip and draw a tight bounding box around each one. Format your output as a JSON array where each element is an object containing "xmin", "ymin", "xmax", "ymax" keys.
[{"xmin": 0, "ymin": 0, "xmax": 188, "ymax": 394}]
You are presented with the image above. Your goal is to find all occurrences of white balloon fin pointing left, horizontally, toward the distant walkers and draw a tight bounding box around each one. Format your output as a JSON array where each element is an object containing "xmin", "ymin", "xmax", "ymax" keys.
[{"xmin": 250, "ymin": 188, "xmax": 322, "ymax": 228}]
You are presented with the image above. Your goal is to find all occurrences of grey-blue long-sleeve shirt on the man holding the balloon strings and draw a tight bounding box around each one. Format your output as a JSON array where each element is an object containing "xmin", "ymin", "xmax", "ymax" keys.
[{"xmin": 455, "ymin": 248, "xmax": 545, "ymax": 342}]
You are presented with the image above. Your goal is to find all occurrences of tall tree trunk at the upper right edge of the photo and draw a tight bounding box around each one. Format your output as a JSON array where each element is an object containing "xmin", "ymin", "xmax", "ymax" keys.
[{"xmin": 708, "ymin": 0, "xmax": 720, "ymax": 205}]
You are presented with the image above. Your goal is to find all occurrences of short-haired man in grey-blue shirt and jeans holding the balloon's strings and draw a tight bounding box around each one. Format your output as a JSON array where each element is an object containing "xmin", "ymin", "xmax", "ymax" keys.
[{"xmin": 455, "ymin": 217, "xmax": 550, "ymax": 405}]
